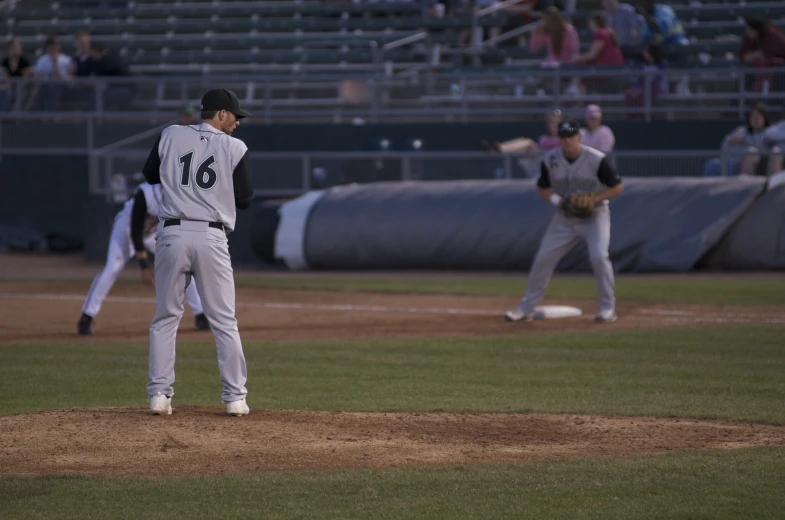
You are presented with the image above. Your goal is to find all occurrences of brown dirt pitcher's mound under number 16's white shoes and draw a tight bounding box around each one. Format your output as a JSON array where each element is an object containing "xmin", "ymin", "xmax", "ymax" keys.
[{"xmin": 0, "ymin": 406, "xmax": 785, "ymax": 475}]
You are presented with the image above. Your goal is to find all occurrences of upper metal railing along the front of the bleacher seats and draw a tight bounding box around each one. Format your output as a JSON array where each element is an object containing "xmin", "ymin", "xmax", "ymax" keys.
[{"xmin": 0, "ymin": 65, "xmax": 785, "ymax": 124}]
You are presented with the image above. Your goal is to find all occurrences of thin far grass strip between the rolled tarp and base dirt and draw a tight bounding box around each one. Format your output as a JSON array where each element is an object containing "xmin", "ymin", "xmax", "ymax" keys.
[{"xmin": 231, "ymin": 274, "xmax": 785, "ymax": 305}]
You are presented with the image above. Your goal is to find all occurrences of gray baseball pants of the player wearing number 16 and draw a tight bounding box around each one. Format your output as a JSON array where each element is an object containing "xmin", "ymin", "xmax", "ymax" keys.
[{"xmin": 147, "ymin": 220, "xmax": 248, "ymax": 403}]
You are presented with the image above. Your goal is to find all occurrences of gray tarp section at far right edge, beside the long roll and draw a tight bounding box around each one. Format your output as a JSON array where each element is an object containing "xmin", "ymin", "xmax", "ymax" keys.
[{"xmin": 706, "ymin": 186, "xmax": 785, "ymax": 270}]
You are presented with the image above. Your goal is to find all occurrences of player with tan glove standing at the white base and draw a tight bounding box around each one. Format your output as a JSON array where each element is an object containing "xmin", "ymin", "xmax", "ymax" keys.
[{"xmin": 504, "ymin": 120, "xmax": 624, "ymax": 323}]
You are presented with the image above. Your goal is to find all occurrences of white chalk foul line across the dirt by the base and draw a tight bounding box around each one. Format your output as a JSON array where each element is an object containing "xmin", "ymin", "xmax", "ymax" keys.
[{"xmin": 0, "ymin": 293, "xmax": 785, "ymax": 323}]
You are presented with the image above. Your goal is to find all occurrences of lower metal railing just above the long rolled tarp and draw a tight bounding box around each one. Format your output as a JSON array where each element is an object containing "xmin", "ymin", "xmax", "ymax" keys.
[{"xmin": 91, "ymin": 147, "xmax": 765, "ymax": 200}]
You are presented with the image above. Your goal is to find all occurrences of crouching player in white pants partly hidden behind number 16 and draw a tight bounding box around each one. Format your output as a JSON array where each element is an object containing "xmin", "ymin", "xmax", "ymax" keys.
[{"xmin": 77, "ymin": 182, "xmax": 210, "ymax": 336}]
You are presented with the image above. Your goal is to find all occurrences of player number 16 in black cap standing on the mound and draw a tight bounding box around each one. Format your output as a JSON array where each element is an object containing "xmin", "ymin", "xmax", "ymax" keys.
[{"xmin": 142, "ymin": 89, "xmax": 253, "ymax": 415}]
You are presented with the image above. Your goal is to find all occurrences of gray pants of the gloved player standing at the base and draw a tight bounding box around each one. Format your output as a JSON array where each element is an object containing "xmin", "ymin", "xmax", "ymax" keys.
[{"xmin": 518, "ymin": 205, "xmax": 616, "ymax": 313}]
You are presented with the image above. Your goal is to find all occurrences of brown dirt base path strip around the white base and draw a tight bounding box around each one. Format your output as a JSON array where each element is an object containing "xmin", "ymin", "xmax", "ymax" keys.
[{"xmin": 0, "ymin": 281, "xmax": 785, "ymax": 342}]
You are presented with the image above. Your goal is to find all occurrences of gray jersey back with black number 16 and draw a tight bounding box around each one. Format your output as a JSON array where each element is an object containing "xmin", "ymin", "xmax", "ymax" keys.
[{"xmin": 158, "ymin": 123, "xmax": 248, "ymax": 231}]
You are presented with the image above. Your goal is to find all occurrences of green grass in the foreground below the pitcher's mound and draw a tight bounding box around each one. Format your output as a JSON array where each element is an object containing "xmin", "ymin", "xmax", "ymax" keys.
[{"xmin": 0, "ymin": 448, "xmax": 785, "ymax": 520}]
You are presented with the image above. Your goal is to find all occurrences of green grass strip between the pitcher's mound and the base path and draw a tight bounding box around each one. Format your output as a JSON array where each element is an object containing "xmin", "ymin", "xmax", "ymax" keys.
[{"xmin": 0, "ymin": 325, "xmax": 785, "ymax": 424}]
